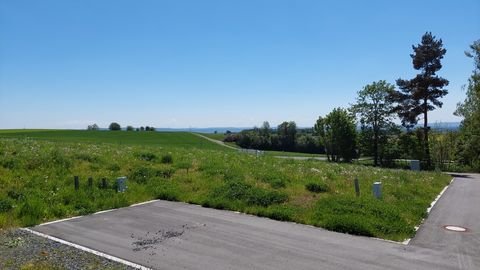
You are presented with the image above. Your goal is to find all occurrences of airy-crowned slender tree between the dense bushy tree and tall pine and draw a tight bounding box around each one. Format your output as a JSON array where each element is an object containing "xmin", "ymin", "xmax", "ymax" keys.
[{"xmin": 351, "ymin": 81, "xmax": 395, "ymax": 166}]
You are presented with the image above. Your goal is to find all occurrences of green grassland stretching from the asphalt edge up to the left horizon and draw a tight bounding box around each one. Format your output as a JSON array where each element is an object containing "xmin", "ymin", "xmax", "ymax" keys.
[{"xmin": 0, "ymin": 131, "xmax": 450, "ymax": 240}]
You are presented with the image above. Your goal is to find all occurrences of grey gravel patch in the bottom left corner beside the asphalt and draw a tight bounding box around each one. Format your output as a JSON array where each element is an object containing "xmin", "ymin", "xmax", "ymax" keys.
[{"xmin": 0, "ymin": 229, "xmax": 135, "ymax": 270}]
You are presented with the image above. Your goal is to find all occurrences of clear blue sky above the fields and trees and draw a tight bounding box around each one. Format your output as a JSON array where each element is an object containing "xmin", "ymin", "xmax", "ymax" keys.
[{"xmin": 0, "ymin": 0, "xmax": 480, "ymax": 128}]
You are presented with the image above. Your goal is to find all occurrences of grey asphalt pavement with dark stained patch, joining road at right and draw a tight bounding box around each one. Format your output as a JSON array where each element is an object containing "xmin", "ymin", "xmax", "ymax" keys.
[{"xmin": 33, "ymin": 176, "xmax": 480, "ymax": 269}]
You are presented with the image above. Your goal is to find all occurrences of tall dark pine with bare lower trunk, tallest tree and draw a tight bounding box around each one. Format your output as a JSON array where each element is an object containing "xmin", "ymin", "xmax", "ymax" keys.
[{"xmin": 391, "ymin": 32, "xmax": 448, "ymax": 167}]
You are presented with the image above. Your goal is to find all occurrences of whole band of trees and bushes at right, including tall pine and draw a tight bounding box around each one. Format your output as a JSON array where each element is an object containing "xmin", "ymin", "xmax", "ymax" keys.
[{"xmin": 231, "ymin": 32, "xmax": 480, "ymax": 171}]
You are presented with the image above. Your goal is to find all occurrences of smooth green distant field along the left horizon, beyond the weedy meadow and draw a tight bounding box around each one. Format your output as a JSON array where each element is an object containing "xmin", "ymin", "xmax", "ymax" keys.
[{"xmin": 0, "ymin": 130, "xmax": 228, "ymax": 150}]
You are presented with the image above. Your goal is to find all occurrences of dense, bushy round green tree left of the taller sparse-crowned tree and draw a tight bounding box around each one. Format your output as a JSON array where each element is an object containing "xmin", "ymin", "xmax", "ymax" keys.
[{"xmin": 314, "ymin": 108, "xmax": 357, "ymax": 162}]
